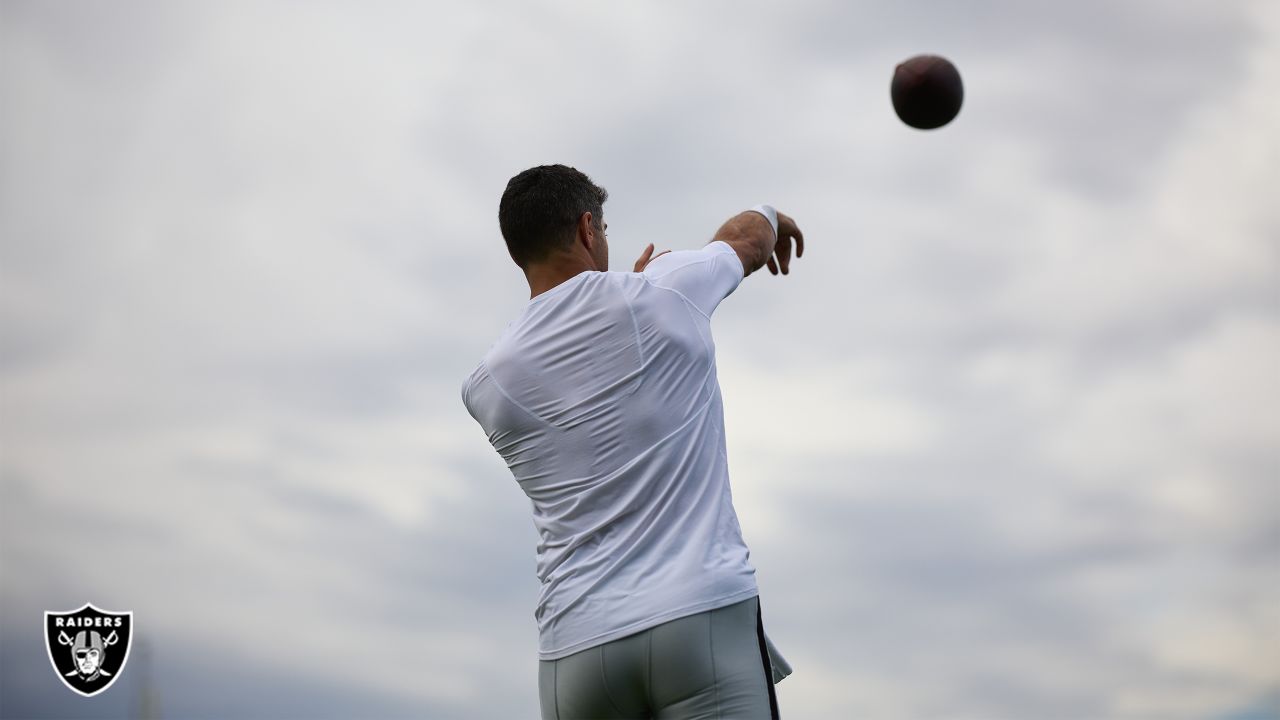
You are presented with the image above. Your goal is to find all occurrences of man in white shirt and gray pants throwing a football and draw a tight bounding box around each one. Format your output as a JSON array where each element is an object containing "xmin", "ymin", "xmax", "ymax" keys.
[{"xmin": 462, "ymin": 165, "xmax": 804, "ymax": 720}]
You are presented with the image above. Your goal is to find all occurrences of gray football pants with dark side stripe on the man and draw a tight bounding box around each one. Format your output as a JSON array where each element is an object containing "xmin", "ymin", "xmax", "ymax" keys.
[{"xmin": 538, "ymin": 597, "xmax": 778, "ymax": 720}]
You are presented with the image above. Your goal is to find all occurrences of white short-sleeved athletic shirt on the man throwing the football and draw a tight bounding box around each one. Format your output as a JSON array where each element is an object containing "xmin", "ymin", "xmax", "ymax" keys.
[{"xmin": 462, "ymin": 242, "xmax": 758, "ymax": 660}]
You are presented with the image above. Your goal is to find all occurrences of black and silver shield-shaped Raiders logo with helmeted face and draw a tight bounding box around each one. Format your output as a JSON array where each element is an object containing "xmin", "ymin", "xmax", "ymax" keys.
[{"xmin": 45, "ymin": 603, "xmax": 133, "ymax": 697}]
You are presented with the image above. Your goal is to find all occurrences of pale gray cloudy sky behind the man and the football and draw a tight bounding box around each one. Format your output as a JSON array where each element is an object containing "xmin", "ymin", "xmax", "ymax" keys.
[{"xmin": 0, "ymin": 0, "xmax": 1280, "ymax": 720}]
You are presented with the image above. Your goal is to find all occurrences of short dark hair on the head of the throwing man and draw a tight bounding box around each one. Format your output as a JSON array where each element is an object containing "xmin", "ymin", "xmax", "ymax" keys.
[{"xmin": 498, "ymin": 165, "xmax": 609, "ymax": 268}]
